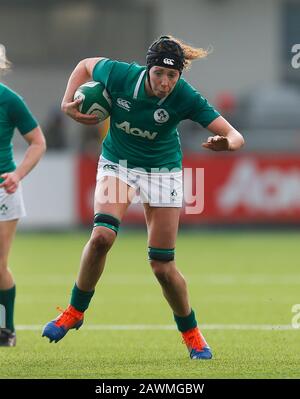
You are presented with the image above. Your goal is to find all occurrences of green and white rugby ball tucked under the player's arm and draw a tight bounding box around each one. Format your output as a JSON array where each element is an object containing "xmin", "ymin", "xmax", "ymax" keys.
[{"xmin": 74, "ymin": 81, "xmax": 111, "ymax": 122}]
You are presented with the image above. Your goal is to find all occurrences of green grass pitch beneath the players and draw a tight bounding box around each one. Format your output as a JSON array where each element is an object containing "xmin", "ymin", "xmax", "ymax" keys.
[{"xmin": 0, "ymin": 231, "xmax": 300, "ymax": 379}]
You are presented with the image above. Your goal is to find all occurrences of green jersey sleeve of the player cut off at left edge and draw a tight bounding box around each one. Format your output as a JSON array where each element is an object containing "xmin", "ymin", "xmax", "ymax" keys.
[{"xmin": 8, "ymin": 92, "xmax": 38, "ymax": 135}]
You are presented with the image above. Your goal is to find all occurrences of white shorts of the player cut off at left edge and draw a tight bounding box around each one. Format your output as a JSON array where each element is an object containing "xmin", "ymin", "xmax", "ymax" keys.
[{"xmin": 0, "ymin": 183, "xmax": 26, "ymax": 222}]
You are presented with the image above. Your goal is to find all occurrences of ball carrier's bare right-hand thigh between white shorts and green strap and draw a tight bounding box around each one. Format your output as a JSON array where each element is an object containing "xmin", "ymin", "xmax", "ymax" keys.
[{"xmin": 144, "ymin": 204, "xmax": 181, "ymax": 248}]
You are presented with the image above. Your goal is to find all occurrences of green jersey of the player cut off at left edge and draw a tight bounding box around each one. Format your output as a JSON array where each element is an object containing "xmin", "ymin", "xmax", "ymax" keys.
[{"xmin": 0, "ymin": 83, "xmax": 38, "ymax": 174}]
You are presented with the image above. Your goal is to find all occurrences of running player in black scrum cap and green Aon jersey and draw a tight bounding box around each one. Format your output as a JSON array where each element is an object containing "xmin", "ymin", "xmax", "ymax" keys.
[{"xmin": 43, "ymin": 36, "xmax": 244, "ymax": 359}]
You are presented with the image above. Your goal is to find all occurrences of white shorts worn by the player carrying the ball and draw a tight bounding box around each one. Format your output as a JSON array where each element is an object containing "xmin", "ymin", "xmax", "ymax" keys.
[{"xmin": 97, "ymin": 155, "xmax": 183, "ymax": 208}]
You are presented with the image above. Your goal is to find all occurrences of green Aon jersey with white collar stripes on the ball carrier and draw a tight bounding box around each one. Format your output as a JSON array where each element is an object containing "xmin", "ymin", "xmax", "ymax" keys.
[{"xmin": 93, "ymin": 58, "xmax": 220, "ymax": 171}]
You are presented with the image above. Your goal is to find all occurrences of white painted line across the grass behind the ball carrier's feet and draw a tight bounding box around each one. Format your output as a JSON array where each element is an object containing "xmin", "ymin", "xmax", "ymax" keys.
[{"xmin": 16, "ymin": 324, "xmax": 295, "ymax": 331}]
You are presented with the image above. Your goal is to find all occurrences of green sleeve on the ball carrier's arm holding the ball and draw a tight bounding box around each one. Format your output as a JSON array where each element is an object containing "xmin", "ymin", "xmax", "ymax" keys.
[{"xmin": 92, "ymin": 58, "xmax": 130, "ymax": 91}]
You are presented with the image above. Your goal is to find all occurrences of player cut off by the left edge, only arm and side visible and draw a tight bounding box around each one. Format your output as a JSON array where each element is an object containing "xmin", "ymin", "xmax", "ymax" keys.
[{"xmin": 0, "ymin": 44, "xmax": 46, "ymax": 346}]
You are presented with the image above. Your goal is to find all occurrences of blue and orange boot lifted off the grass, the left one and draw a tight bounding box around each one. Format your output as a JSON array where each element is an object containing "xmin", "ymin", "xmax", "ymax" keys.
[{"xmin": 42, "ymin": 305, "xmax": 83, "ymax": 343}]
